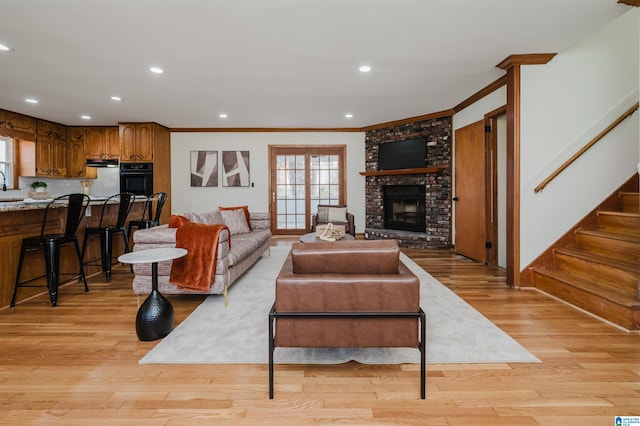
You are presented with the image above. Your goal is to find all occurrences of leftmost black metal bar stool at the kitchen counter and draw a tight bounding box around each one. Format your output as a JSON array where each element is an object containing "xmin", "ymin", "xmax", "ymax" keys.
[{"xmin": 11, "ymin": 194, "xmax": 89, "ymax": 307}]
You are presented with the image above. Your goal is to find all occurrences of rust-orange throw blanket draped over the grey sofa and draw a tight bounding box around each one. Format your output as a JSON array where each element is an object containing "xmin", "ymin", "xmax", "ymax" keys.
[{"xmin": 169, "ymin": 222, "xmax": 231, "ymax": 291}]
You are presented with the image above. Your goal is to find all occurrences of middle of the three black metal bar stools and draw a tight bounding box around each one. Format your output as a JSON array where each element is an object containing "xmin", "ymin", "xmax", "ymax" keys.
[{"xmin": 82, "ymin": 192, "xmax": 136, "ymax": 282}]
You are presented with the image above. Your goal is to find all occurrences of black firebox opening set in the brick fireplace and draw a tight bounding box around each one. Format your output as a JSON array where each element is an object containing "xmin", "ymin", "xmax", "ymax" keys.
[{"xmin": 383, "ymin": 185, "xmax": 427, "ymax": 232}]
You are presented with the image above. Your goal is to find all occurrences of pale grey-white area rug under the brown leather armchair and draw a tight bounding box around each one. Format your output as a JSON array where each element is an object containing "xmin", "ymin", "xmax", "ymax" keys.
[{"xmin": 140, "ymin": 247, "xmax": 540, "ymax": 364}]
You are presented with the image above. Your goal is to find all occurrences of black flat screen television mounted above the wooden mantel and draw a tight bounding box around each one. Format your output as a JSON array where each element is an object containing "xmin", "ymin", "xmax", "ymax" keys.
[{"xmin": 378, "ymin": 138, "xmax": 427, "ymax": 170}]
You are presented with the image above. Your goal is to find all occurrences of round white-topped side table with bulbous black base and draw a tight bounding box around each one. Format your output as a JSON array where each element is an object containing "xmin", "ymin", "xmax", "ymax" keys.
[{"xmin": 118, "ymin": 247, "xmax": 187, "ymax": 341}]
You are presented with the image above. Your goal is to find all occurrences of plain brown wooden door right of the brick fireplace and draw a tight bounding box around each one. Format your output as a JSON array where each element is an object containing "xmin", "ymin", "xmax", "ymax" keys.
[{"xmin": 454, "ymin": 120, "xmax": 487, "ymax": 262}]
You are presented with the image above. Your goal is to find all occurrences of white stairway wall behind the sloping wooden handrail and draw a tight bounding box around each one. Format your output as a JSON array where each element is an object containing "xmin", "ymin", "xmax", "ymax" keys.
[{"xmin": 520, "ymin": 8, "xmax": 640, "ymax": 268}]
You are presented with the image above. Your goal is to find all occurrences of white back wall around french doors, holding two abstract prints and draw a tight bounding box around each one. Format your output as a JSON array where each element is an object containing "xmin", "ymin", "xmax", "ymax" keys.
[{"xmin": 171, "ymin": 132, "xmax": 365, "ymax": 226}]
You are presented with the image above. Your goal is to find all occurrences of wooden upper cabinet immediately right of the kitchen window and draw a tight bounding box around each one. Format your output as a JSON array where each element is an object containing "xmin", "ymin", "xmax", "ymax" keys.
[{"xmin": 36, "ymin": 120, "xmax": 68, "ymax": 177}]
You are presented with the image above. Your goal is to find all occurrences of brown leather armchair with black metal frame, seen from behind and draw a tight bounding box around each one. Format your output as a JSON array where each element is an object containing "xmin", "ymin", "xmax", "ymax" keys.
[{"xmin": 269, "ymin": 240, "xmax": 426, "ymax": 399}]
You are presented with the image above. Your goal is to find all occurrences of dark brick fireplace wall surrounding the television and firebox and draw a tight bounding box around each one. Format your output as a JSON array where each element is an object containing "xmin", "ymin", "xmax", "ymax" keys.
[{"xmin": 364, "ymin": 116, "xmax": 451, "ymax": 248}]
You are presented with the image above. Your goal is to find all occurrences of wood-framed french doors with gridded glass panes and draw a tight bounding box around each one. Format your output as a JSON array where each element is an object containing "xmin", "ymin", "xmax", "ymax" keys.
[{"xmin": 269, "ymin": 145, "xmax": 346, "ymax": 234}]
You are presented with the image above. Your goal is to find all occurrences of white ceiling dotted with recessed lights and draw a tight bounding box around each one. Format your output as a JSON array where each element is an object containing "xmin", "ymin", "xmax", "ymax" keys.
[{"xmin": 0, "ymin": 0, "xmax": 630, "ymax": 128}]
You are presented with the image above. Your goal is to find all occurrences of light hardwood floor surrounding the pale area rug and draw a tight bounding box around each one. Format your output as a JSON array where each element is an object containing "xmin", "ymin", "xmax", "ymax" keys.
[{"xmin": 0, "ymin": 238, "xmax": 640, "ymax": 426}]
